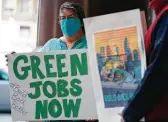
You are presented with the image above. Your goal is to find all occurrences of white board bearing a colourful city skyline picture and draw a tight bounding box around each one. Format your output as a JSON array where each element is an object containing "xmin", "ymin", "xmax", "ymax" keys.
[{"xmin": 84, "ymin": 9, "xmax": 146, "ymax": 122}]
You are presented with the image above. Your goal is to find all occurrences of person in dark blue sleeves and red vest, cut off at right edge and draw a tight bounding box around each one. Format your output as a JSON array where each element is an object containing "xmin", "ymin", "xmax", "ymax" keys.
[{"xmin": 122, "ymin": 0, "xmax": 168, "ymax": 122}]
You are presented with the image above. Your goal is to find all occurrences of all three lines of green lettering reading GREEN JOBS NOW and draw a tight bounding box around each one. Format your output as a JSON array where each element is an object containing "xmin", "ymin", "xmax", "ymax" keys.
[{"xmin": 13, "ymin": 53, "xmax": 88, "ymax": 119}]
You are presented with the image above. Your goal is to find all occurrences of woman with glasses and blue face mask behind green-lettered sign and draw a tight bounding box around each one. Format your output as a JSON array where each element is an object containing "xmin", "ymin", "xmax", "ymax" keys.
[{"xmin": 41, "ymin": 2, "xmax": 97, "ymax": 122}]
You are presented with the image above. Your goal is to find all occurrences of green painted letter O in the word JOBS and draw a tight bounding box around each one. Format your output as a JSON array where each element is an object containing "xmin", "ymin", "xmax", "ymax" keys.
[{"xmin": 43, "ymin": 81, "xmax": 56, "ymax": 98}]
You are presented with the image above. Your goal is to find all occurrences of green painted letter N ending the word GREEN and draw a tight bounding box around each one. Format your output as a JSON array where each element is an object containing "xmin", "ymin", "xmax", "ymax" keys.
[{"xmin": 70, "ymin": 53, "xmax": 88, "ymax": 76}]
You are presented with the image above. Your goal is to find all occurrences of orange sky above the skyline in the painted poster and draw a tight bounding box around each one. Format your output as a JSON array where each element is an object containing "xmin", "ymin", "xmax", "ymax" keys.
[{"xmin": 95, "ymin": 26, "xmax": 139, "ymax": 61}]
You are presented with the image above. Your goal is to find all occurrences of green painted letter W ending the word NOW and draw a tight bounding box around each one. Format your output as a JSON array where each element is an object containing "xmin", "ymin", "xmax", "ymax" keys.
[{"xmin": 63, "ymin": 98, "xmax": 81, "ymax": 118}]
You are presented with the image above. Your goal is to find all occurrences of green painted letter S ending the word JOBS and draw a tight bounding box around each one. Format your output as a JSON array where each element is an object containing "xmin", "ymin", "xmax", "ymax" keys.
[{"xmin": 70, "ymin": 79, "xmax": 82, "ymax": 97}]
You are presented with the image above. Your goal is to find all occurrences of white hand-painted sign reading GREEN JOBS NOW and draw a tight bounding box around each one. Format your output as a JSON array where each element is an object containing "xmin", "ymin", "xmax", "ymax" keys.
[{"xmin": 8, "ymin": 50, "xmax": 97, "ymax": 121}]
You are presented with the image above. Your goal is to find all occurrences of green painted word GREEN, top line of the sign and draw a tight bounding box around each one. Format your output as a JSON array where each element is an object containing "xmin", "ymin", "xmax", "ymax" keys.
[{"xmin": 13, "ymin": 53, "xmax": 88, "ymax": 80}]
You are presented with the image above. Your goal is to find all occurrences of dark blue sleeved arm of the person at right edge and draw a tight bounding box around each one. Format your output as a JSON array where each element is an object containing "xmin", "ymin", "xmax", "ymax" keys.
[{"xmin": 123, "ymin": 16, "xmax": 168, "ymax": 122}]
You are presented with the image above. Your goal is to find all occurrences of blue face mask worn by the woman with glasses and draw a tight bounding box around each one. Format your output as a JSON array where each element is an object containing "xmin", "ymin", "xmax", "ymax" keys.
[{"xmin": 60, "ymin": 18, "xmax": 81, "ymax": 36}]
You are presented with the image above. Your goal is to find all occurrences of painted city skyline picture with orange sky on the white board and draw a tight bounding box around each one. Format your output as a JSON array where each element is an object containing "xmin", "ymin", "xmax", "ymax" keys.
[{"xmin": 94, "ymin": 26, "xmax": 142, "ymax": 108}]
